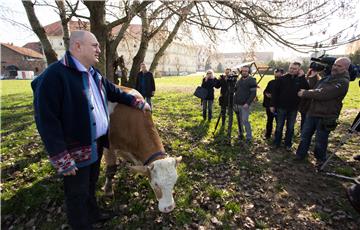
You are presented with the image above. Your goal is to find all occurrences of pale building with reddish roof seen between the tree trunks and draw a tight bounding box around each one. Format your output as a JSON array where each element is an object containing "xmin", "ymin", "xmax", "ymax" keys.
[{"xmin": 44, "ymin": 21, "xmax": 198, "ymax": 75}]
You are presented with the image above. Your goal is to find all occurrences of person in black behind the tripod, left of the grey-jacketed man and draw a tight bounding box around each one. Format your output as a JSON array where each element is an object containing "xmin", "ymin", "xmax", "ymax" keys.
[{"xmin": 215, "ymin": 68, "xmax": 231, "ymax": 126}]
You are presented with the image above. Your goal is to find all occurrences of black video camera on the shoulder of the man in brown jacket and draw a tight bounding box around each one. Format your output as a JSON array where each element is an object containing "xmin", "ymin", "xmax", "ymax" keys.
[{"xmin": 310, "ymin": 55, "xmax": 360, "ymax": 81}]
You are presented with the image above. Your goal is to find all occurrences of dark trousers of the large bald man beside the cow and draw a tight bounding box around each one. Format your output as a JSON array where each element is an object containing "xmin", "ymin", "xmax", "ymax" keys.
[{"xmin": 63, "ymin": 138, "xmax": 103, "ymax": 230}]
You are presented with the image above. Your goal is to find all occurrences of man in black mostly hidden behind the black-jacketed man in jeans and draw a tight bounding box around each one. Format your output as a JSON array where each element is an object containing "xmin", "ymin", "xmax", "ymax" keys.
[{"xmin": 263, "ymin": 69, "xmax": 284, "ymax": 139}]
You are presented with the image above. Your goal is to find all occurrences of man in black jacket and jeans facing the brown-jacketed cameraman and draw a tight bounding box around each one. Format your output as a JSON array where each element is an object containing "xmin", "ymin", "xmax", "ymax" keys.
[{"xmin": 270, "ymin": 62, "xmax": 309, "ymax": 150}]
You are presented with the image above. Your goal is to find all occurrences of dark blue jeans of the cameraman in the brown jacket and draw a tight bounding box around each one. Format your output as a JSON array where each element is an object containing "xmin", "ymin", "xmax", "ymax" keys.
[{"xmin": 296, "ymin": 116, "xmax": 330, "ymax": 161}]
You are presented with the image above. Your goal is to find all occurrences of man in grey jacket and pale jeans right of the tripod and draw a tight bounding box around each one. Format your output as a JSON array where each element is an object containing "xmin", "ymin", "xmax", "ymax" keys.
[{"xmin": 234, "ymin": 66, "xmax": 257, "ymax": 143}]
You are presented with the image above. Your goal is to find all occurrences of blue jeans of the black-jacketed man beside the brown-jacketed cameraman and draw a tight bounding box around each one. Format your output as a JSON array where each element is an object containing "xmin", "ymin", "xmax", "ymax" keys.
[{"xmin": 274, "ymin": 108, "xmax": 297, "ymax": 147}]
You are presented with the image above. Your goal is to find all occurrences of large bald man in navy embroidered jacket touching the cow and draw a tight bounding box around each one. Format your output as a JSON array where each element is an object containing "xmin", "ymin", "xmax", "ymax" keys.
[{"xmin": 31, "ymin": 31, "xmax": 150, "ymax": 229}]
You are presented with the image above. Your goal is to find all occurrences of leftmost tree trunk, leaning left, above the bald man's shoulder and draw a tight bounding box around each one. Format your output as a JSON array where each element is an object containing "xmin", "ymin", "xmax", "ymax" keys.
[{"xmin": 22, "ymin": 1, "xmax": 58, "ymax": 65}]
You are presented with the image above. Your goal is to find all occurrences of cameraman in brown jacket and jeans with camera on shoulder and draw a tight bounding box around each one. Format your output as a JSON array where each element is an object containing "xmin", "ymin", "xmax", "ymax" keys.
[{"xmin": 296, "ymin": 57, "xmax": 351, "ymax": 169}]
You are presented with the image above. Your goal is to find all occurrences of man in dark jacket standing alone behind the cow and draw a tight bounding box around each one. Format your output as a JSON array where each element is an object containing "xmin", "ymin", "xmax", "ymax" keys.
[{"xmin": 135, "ymin": 63, "xmax": 155, "ymax": 106}]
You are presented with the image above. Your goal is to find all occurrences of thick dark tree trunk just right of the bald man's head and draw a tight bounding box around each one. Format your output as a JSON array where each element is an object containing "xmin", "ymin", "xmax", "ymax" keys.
[{"xmin": 84, "ymin": 1, "xmax": 107, "ymax": 77}]
